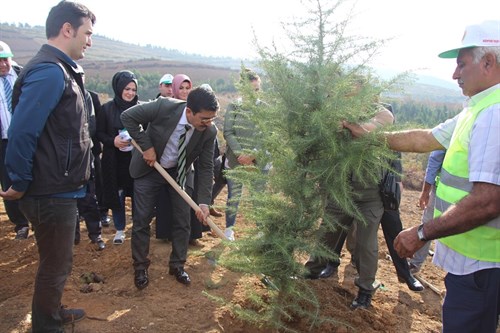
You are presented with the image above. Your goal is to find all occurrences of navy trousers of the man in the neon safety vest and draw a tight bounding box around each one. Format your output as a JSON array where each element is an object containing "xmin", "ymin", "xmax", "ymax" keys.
[{"xmin": 443, "ymin": 268, "xmax": 500, "ymax": 333}]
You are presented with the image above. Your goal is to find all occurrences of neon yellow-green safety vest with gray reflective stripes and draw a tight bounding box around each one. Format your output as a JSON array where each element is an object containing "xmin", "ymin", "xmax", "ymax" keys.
[{"xmin": 434, "ymin": 89, "xmax": 500, "ymax": 262}]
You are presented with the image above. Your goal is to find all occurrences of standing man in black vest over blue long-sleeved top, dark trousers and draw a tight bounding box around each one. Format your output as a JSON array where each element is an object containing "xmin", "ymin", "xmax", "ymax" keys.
[{"xmin": 0, "ymin": 1, "xmax": 95, "ymax": 332}]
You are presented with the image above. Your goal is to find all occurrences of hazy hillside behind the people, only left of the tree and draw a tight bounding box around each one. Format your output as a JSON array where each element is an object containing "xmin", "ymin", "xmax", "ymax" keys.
[{"xmin": 0, "ymin": 23, "xmax": 241, "ymax": 100}]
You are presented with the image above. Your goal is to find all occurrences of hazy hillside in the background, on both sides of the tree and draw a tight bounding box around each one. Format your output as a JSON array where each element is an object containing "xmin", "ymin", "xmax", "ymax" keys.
[{"xmin": 0, "ymin": 23, "xmax": 463, "ymax": 104}]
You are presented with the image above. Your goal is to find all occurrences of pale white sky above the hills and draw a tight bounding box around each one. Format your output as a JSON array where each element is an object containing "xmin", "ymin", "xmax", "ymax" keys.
[{"xmin": 0, "ymin": 0, "xmax": 500, "ymax": 82}]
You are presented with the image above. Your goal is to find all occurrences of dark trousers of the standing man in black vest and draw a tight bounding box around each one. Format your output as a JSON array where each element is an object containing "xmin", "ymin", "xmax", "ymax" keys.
[{"xmin": 19, "ymin": 198, "xmax": 77, "ymax": 333}]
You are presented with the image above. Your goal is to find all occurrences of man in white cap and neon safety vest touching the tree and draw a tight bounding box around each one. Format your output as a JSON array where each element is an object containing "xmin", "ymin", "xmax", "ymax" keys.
[{"xmin": 344, "ymin": 21, "xmax": 500, "ymax": 333}]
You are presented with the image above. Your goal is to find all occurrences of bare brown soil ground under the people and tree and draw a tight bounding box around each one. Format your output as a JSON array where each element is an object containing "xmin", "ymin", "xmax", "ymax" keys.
[{"xmin": 0, "ymin": 190, "xmax": 445, "ymax": 333}]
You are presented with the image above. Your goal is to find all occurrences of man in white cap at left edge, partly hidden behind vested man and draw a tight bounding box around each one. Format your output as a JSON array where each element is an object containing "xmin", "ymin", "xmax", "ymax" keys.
[{"xmin": 0, "ymin": 41, "xmax": 29, "ymax": 239}]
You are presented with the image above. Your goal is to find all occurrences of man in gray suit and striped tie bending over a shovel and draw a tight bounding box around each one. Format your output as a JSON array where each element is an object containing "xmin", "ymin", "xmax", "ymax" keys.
[{"xmin": 121, "ymin": 88, "xmax": 219, "ymax": 289}]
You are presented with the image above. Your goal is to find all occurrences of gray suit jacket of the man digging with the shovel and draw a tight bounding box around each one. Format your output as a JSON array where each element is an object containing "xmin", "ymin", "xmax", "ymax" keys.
[{"xmin": 120, "ymin": 98, "xmax": 217, "ymax": 204}]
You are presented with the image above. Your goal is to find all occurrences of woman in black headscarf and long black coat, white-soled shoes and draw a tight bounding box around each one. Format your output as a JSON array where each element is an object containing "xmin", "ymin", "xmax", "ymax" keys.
[{"xmin": 96, "ymin": 70, "xmax": 139, "ymax": 244}]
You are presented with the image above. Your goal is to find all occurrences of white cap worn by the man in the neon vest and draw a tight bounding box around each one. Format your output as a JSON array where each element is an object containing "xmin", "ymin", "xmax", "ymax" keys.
[{"xmin": 438, "ymin": 20, "xmax": 500, "ymax": 58}]
